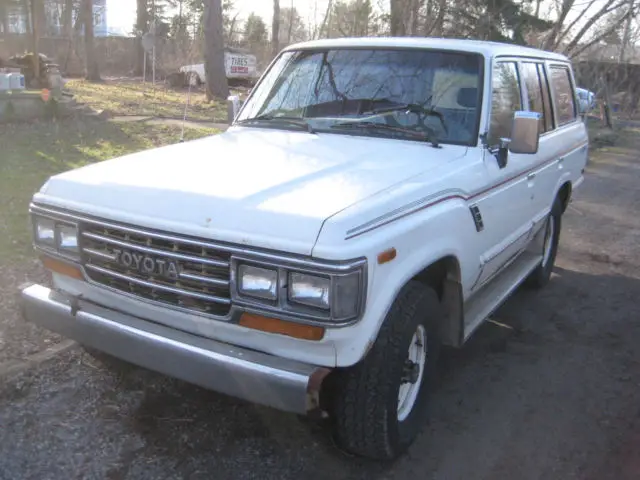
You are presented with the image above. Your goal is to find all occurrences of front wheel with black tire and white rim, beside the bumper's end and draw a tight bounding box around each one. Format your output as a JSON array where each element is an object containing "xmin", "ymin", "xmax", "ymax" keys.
[{"xmin": 331, "ymin": 281, "xmax": 441, "ymax": 460}]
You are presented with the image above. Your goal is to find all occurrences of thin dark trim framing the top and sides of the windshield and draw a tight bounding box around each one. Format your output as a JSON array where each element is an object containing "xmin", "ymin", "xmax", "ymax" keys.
[{"xmin": 235, "ymin": 45, "xmax": 486, "ymax": 147}]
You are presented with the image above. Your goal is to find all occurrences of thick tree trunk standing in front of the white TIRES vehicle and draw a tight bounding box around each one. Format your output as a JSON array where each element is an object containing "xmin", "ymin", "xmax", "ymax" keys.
[{"xmin": 204, "ymin": 0, "xmax": 229, "ymax": 101}]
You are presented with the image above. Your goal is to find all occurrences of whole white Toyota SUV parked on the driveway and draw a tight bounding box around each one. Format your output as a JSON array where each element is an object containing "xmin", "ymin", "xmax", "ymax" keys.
[{"xmin": 22, "ymin": 38, "xmax": 588, "ymax": 459}]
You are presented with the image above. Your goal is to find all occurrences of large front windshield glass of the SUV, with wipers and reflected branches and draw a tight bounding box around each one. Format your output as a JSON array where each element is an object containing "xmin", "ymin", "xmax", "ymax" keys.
[{"xmin": 238, "ymin": 49, "xmax": 482, "ymax": 145}]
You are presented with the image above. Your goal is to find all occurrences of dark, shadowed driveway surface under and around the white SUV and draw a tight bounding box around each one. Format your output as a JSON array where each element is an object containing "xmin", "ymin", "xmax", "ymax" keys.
[{"xmin": 0, "ymin": 132, "xmax": 640, "ymax": 480}]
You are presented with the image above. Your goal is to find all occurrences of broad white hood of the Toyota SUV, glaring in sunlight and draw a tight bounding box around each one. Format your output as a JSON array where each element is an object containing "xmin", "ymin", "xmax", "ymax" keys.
[{"xmin": 34, "ymin": 127, "xmax": 466, "ymax": 255}]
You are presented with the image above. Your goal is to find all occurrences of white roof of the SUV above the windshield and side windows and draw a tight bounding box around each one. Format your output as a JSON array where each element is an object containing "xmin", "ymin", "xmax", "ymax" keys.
[{"xmin": 285, "ymin": 37, "xmax": 569, "ymax": 62}]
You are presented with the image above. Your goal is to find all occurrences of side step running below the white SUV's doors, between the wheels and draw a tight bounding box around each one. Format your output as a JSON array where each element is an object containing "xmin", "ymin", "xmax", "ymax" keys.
[{"xmin": 464, "ymin": 250, "xmax": 542, "ymax": 341}]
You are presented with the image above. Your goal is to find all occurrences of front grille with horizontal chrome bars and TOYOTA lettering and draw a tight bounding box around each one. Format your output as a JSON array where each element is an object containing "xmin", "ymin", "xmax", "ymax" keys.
[{"xmin": 80, "ymin": 223, "xmax": 231, "ymax": 316}]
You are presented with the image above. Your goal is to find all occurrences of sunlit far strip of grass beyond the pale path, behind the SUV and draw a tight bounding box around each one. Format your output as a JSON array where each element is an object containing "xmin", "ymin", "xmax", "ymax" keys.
[{"xmin": 66, "ymin": 79, "xmax": 234, "ymax": 122}]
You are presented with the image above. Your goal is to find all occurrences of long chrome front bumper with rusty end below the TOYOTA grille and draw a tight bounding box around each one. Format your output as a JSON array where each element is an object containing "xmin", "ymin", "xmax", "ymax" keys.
[{"xmin": 22, "ymin": 285, "xmax": 329, "ymax": 414}]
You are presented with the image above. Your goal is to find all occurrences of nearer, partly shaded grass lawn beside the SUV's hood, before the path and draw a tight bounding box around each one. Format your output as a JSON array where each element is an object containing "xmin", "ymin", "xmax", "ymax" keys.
[{"xmin": 0, "ymin": 118, "xmax": 216, "ymax": 269}]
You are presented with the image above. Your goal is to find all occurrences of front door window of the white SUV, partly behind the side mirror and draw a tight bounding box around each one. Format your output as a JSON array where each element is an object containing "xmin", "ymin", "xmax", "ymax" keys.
[{"xmin": 488, "ymin": 62, "xmax": 522, "ymax": 146}]
